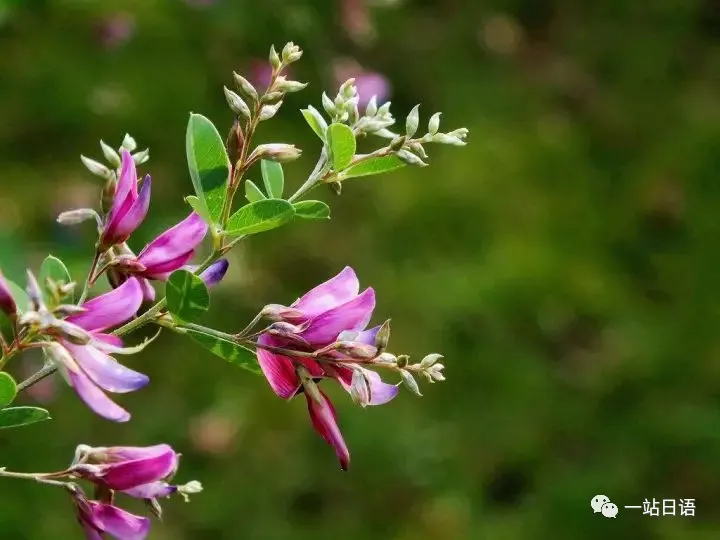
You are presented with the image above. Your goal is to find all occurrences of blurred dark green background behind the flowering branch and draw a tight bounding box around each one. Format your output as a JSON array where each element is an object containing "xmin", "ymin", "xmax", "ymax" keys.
[{"xmin": 0, "ymin": 0, "xmax": 720, "ymax": 540}]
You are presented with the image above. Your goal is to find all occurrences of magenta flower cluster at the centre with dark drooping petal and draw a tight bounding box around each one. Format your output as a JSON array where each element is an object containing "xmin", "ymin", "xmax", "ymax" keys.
[{"xmin": 257, "ymin": 267, "xmax": 398, "ymax": 469}]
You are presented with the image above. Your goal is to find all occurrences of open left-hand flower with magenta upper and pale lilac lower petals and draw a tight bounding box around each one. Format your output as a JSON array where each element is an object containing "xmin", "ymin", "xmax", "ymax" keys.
[{"xmin": 47, "ymin": 279, "xmax": 149, "ymax": 422}]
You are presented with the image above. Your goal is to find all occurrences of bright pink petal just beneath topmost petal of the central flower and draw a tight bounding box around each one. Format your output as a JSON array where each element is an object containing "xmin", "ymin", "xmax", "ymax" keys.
[{"xmin": 302, "ymin": 288, "xmax": 375, "ymax": 346}]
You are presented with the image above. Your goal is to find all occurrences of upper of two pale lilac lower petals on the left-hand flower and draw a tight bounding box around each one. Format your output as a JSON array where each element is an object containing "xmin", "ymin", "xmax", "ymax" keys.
[{"xmin": 63, "ymin": 343, "xmax": 150, "ymax": 394}]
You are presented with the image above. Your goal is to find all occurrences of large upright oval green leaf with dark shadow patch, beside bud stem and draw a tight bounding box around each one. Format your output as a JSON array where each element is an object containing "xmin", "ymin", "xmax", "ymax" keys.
[{"xmin": 185, "ymin": 114, "xmax": 230, "ymax": 223}]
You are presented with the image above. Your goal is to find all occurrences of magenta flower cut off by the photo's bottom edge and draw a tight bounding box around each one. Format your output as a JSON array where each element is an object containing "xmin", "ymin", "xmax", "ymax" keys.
[{"xmin": 73, "ymin": 488, "xmax": 150, "ymax": 540}]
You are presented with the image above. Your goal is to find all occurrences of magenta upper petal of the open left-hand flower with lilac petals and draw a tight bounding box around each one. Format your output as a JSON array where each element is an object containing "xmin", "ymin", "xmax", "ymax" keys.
[{"xmin": 66, "ymin": 278, "xmax": 142, "ymax": 332}]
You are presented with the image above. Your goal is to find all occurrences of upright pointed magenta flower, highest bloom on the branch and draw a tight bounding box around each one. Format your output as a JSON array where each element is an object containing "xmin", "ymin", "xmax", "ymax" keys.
[{"xmin": 100, "ymin": 150, "xmax": 151, "ymax": 250}]
